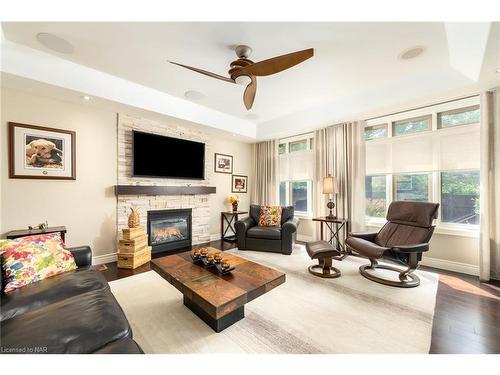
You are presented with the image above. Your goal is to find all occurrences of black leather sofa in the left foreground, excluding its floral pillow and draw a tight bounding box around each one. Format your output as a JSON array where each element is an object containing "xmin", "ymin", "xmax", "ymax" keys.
[{"xmin": 0, "ymin": 246, "xmax": 143, "ymax": 354}]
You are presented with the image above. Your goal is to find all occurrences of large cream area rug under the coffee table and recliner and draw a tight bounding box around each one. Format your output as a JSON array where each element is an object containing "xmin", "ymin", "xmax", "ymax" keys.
[{"xmin": 110, "ymin": 245, "xmax": 438, "ymax": 354}]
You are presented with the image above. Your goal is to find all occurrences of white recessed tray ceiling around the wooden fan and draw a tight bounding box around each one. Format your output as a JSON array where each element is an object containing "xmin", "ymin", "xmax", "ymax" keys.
[{"xmin": 2, "ymin": 22, "xmax": 500, "ymax": 136}]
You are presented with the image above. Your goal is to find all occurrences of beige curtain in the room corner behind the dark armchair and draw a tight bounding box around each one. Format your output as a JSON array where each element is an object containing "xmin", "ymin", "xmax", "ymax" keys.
[{"xmin": 251, "ymin": 140, "xmax": 278, "ymax": 205}]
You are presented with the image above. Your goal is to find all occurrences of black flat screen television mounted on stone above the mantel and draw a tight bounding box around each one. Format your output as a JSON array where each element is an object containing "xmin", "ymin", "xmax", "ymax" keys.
[{"xmin": 132, "ymin": 130, "xmax": 205, "ymax": 180}]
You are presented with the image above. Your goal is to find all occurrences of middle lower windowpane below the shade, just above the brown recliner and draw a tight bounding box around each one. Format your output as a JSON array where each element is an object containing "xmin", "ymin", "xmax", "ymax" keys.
[{"xmin": 393, "ymin": 173, "xmax": 430, "ymax": 202}]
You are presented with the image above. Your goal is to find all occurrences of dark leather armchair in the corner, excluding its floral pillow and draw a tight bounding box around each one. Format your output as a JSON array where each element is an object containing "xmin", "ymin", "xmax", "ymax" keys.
[{"xmin": 234, "ymin": 204, "xmax": 299, "ymax": 255}]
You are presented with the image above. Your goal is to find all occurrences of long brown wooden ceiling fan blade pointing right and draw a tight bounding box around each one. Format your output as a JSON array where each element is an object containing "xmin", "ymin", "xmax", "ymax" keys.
[{"xmin": 232, "ymin": 48, "xmax": 314, "ymax": 77}]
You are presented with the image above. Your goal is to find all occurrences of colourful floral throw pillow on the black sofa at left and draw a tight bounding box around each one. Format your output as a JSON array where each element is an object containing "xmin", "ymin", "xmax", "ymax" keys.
[{"xmin": 2, "ymin": 233, "xmax": 77, "ymax": 293}]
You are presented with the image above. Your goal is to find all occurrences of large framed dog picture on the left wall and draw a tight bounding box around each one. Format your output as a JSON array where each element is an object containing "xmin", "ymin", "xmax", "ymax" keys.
[{"xmin": 9, "ymin": 122, "xmax": 76, "ymax": 180}]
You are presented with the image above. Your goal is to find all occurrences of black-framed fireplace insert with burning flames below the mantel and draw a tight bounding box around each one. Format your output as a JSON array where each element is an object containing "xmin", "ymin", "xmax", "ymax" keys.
[{"xmin": 148, "ymin": 208, "xmax": 192, "ymax": 253}]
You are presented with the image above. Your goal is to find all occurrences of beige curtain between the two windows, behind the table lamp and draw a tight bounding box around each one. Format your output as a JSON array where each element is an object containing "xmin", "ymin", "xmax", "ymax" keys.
[{"xmin": 314, "ymin": 122, "xmax": 365, "ymax": 237}]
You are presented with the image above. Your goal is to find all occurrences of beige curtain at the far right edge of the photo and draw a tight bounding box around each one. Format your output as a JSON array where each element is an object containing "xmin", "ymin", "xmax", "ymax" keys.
[{"xmin": 479, "ymin": 90, "xmax": 500, "ymax": 281}]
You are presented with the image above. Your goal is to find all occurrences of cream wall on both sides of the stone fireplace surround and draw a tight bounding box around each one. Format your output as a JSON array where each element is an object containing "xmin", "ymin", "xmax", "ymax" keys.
[{"xmin": 0, "ymin": 88, "xmax": 251, "ymax": 256}]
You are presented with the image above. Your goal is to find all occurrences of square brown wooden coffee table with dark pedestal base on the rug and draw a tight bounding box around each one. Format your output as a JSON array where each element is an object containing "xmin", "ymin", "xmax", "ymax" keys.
[{"xmin": 151, "ymin": 247, "xmax": 285, "ymax": 332}]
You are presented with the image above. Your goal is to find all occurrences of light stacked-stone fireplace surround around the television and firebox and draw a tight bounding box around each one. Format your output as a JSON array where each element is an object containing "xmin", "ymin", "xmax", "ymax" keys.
[{"xmin": 116, "ymin": 114, "xmax": 213, "ymax": 250}]
